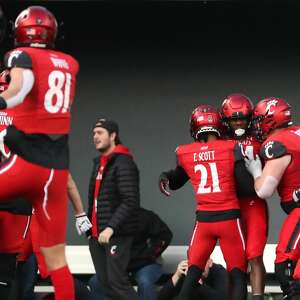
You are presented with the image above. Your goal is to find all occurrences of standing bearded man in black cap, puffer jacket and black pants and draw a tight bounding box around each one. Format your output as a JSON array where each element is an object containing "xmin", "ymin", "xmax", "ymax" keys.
[{"xmin": 88, "ymin": 119, "xmax": 140, "ymax": 300}]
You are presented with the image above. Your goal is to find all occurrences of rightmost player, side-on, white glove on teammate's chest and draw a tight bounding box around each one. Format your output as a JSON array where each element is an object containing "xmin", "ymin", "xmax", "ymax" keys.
[{"xmin": 245, "ymin": 97, "xmax": 300, "ymax": 299}]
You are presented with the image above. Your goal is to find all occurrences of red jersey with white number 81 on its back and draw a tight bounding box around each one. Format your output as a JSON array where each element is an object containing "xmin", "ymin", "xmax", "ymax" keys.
[{"xmin": 4, "ymin": 47, "xmax": 79, "ymax": 134}]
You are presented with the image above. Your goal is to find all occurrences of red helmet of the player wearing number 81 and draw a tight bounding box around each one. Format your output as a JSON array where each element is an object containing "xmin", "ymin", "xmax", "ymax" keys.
[{"xmin": 15, "ymin": 6, "xmax": 57, "ymax": 48}]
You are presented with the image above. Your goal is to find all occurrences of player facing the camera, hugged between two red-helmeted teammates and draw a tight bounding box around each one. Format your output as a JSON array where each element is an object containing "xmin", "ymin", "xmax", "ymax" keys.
[{"xmin": 221, "ymin": 94, "xmax": 268, "ymax": 300}]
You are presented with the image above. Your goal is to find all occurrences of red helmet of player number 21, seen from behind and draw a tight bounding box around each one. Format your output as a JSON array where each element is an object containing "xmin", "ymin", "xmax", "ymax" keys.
[{"xmin": 190, "ymin": 104, "xmax": 221, "ymax": 140}]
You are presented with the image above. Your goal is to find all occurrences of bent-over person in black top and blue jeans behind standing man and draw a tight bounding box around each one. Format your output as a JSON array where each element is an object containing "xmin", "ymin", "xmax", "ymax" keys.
[{"xmin": 89, "ymin": 208, "xmax": 173, "ymax": 300}]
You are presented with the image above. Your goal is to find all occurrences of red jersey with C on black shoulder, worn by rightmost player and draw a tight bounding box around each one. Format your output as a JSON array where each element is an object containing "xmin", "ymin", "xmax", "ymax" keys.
[{"xmin": 261, "ymin": 126, "xmax": 300, "ymax": 202}]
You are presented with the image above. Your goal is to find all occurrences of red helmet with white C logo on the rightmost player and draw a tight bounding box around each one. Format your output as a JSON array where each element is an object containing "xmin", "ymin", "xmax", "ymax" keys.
[{"xmin": 252, "ymin": 97, "xmax": 293, "ymax": 140}]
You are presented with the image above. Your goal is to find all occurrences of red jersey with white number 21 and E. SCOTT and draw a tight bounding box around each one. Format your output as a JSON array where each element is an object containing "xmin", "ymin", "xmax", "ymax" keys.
[{"xmin": 176, "ymin": 140, "xmax": 239, "ymax": 211}]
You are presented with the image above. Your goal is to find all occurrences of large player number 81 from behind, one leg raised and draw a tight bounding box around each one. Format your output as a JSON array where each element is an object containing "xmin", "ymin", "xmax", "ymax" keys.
[{"xmin": 0, "ymin": 6, "xmax": 79, "ymax": 300}]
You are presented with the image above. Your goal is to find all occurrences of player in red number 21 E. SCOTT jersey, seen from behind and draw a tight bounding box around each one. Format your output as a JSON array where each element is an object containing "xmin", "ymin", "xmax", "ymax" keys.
[{"xmin": 159, "ymin": 105, "xmax": 247, "ymax": 300}]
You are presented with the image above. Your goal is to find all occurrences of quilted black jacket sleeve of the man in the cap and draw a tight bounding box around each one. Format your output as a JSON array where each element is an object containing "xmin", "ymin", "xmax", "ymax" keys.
[{"xmin": 107, "ymin": 156, "xmax": 140, "ymax": 229}]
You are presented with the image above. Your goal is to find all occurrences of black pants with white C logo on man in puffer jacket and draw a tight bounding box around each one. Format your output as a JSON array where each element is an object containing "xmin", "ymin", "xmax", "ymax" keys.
[{"xmin": 89, "ymin": 236, "xmax": 138, "ymax": 300}]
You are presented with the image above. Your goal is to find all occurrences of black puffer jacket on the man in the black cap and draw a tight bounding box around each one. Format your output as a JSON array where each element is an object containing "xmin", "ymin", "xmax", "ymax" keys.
[{"xmin": 88, "ymin": 145, "xmax": 140, "ymax": 236}]
